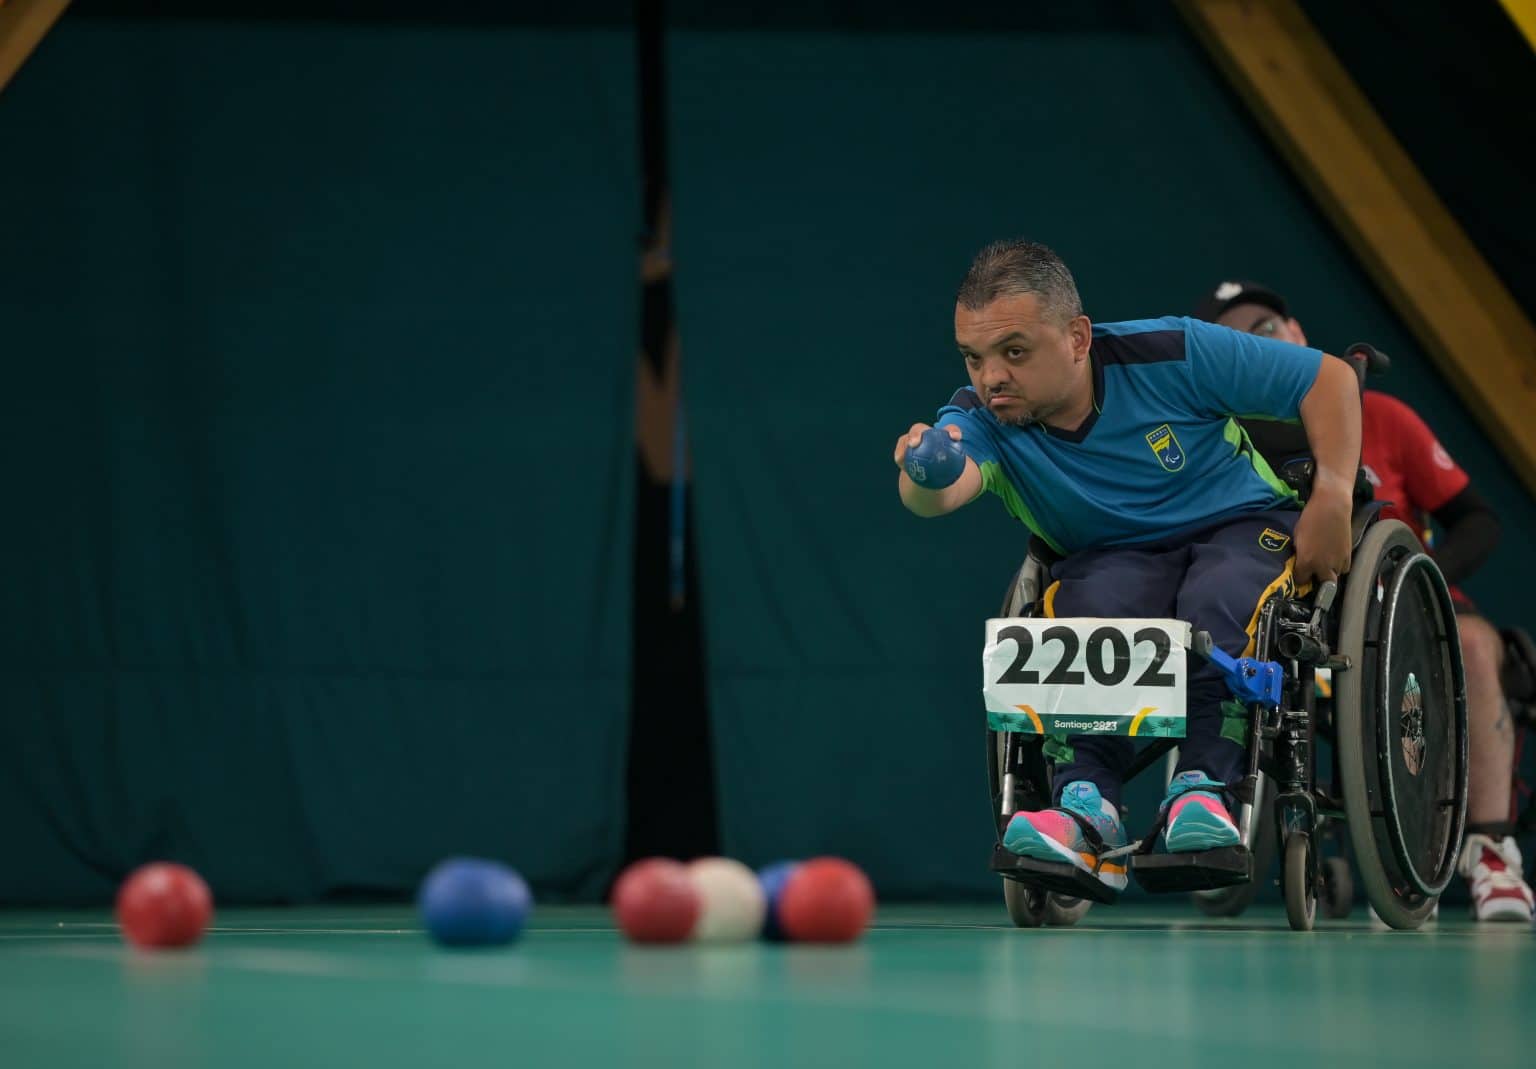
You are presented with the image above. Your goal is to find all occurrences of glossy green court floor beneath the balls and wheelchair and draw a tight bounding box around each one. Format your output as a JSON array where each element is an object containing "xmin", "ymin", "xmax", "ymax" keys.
[{"xmin": 0, "ymin": 903, "xmax": 1536, "ymax": 1069}]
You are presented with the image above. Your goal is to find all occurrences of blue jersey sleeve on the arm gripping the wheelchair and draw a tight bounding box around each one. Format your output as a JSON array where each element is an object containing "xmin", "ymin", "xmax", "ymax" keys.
[{"xmin": 1184, "ymin": 319, "xmax": 1322, "ymax": 419}]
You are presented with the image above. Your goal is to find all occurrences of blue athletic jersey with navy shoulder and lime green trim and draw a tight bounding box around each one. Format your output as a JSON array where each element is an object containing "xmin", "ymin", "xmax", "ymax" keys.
[{"xmin": 938, "ymin": 316, "xmax": 1322, "ymax": 554}]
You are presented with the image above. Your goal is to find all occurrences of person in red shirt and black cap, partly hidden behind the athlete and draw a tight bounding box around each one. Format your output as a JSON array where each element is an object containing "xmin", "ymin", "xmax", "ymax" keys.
[{"xmin": 1195, "ymin": 281, "xmax": 1536, "ymax": 922}]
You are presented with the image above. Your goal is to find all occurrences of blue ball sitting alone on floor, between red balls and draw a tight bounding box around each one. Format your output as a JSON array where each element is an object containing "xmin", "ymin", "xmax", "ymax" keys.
[{"xmin": 419, "ymin": 857, "xmax": 533, "ymax": 946}]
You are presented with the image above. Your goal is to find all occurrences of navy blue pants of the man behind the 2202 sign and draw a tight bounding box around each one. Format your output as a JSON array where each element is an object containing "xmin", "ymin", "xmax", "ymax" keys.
[{"xmin": 1046, "ymin": 510, "xmax": 1301, "ymax": 806}]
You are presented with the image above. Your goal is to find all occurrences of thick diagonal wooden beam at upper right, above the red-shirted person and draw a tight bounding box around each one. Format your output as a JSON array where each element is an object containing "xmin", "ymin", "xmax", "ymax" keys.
[{"xmin": 1178, "ymin": 0, "xmax": 1536, "ymax": 495}]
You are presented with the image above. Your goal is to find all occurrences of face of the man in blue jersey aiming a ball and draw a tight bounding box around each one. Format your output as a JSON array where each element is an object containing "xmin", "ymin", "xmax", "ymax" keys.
[{"xmin": 955, "ymin": 293, "xmax": 1092, "ymax": 425}]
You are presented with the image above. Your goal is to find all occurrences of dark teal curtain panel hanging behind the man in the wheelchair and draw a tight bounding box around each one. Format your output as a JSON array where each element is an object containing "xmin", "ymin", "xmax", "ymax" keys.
[{"xmin": 668, "ymin": 8, "xmax": 1536, "ymax": 895}]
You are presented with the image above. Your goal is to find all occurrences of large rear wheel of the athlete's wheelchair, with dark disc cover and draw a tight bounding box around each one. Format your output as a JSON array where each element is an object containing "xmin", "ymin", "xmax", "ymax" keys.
[{"xmin": 1335, "ymin": 521, "xmax": 1467, "ymax": 928}]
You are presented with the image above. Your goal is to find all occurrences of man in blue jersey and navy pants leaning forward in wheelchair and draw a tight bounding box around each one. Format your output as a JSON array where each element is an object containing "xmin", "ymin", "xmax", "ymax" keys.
[{"xmin": 894, "ymin": 241, "xmax": 1361, "ymax": 897}]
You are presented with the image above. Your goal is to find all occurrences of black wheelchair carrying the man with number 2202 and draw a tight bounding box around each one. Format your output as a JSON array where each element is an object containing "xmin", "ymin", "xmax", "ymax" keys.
[{"xmin": 988, "ymin": 348, "xmax": 1467, "ymax": 931}]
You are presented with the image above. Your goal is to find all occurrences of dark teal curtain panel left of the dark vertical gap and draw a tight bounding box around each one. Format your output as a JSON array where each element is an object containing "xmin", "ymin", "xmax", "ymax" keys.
[{"xmin": 0, "ymin": 17, "xmax": 639, "ymax": 902}]
